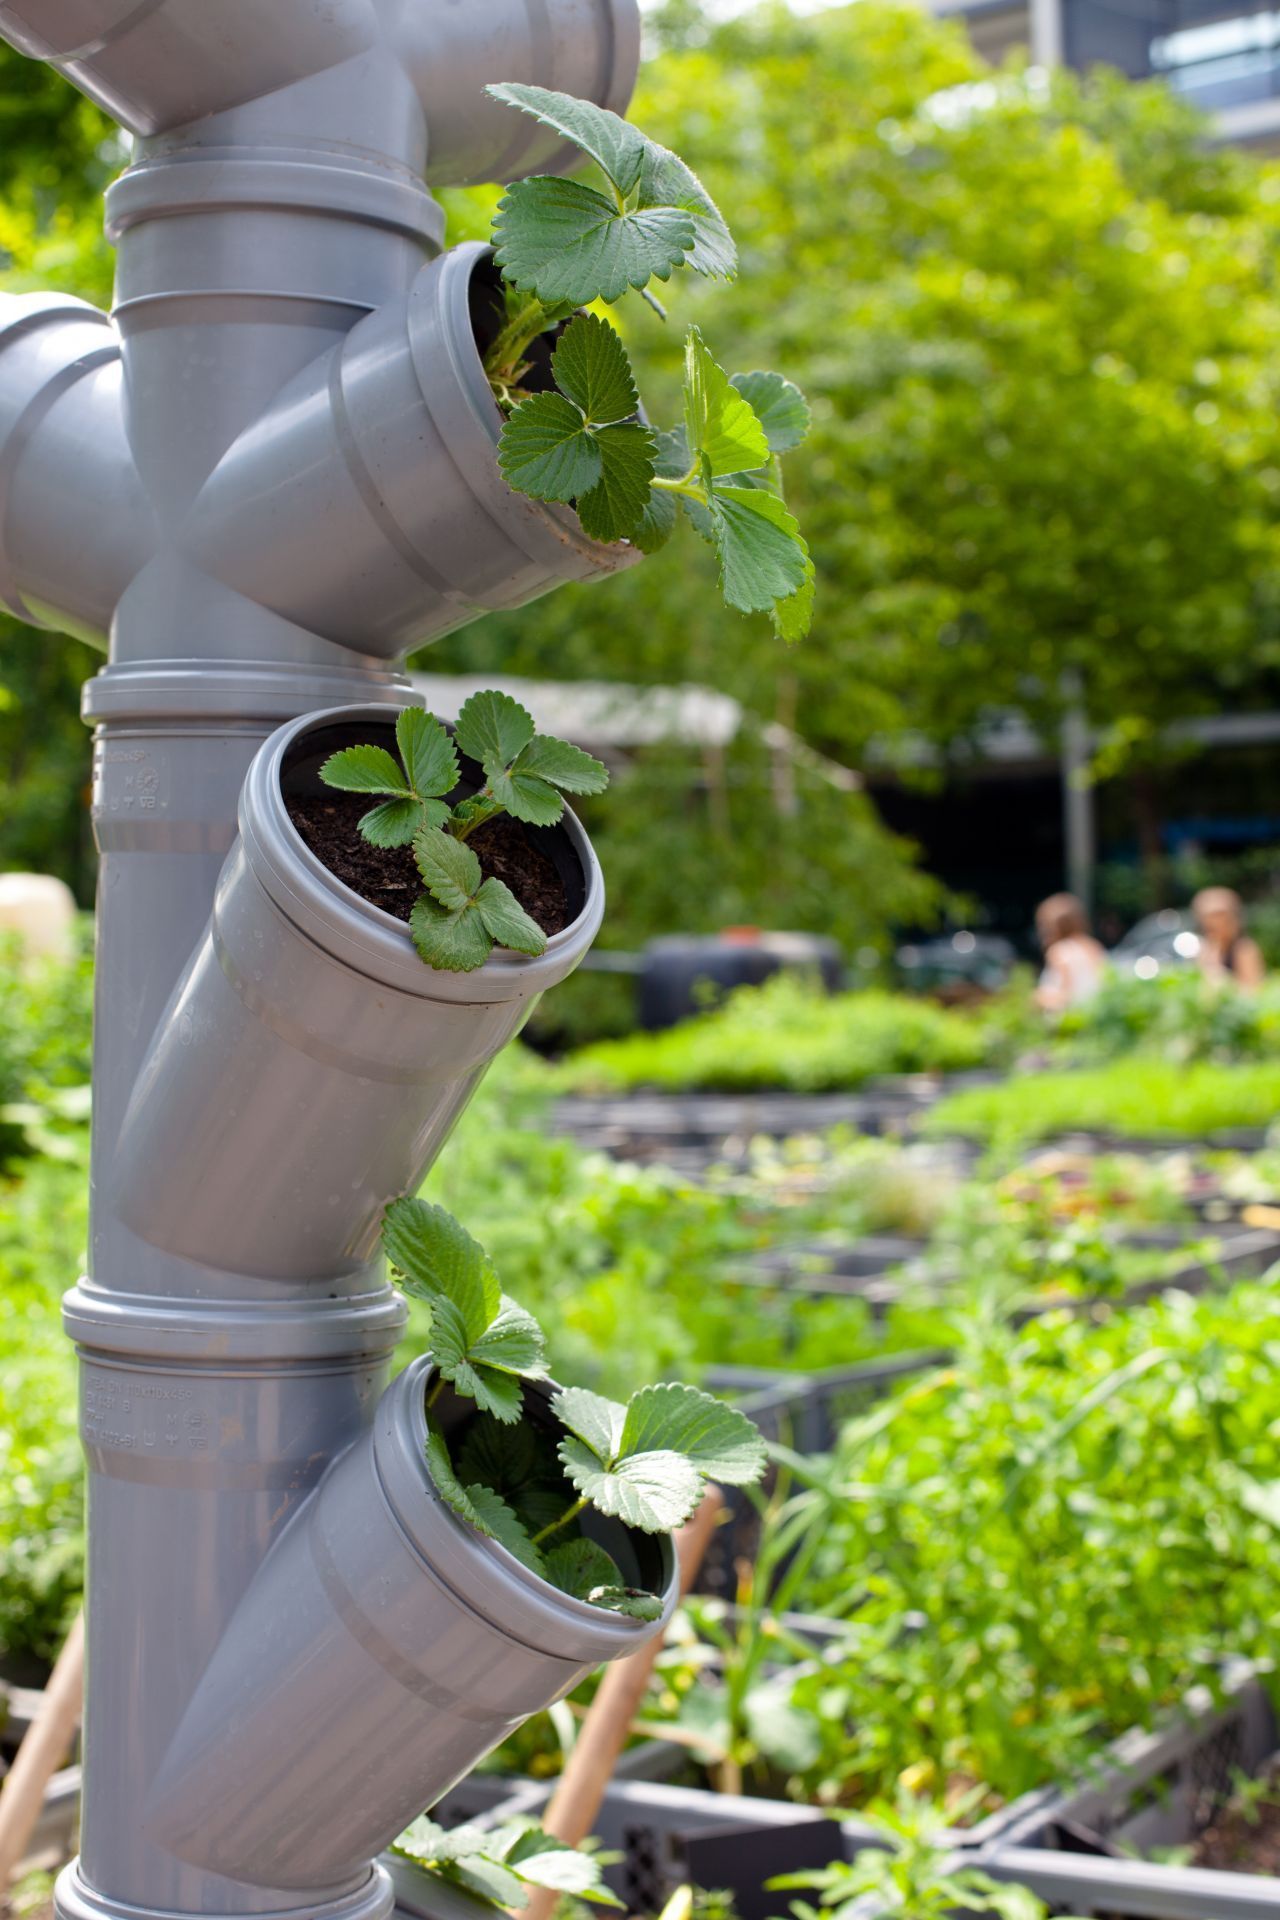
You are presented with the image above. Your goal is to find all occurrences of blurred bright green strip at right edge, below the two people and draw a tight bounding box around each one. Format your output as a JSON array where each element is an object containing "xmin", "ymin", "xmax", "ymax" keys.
[{"xmin": 923, "ymin": 1056, "xmax": 1280, "ymax": 1146}]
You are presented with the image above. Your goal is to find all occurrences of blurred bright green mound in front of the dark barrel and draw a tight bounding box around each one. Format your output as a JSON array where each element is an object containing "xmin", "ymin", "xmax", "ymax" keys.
[{"xmin": 558, "ymin": 973, "xmax": 992, "ymax": 1092}]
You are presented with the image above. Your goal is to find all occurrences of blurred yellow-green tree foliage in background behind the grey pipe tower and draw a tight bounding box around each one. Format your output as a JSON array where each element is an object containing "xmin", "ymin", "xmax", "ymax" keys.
[{"xmin": 0, "ymin": 0, "xmax": 1280, "ymax": 975}]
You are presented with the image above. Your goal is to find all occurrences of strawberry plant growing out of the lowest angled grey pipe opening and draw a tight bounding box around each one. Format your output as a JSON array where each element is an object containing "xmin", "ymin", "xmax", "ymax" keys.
[{"xmin": 382, "ymin": 1200, "xmax": 766, "ymax": 1620}]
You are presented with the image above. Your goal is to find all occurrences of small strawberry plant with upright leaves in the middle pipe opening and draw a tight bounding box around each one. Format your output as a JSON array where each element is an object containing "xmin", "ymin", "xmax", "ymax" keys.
[{"xmin": 320, "ymin": 691, "xmax": 608, "ymax": 973}]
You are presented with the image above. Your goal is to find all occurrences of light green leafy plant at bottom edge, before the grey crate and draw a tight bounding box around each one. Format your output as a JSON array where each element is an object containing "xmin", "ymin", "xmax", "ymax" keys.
[{"xmin": 768, "ymin": 1788, "xmax": 1074, "ymax": 1920}]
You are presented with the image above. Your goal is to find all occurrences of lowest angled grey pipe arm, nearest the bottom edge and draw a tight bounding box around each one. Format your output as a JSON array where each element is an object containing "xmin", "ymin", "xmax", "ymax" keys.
[{"xmin": 146, "ymin": 1359, "xmax": 677, "ymax": 1893}]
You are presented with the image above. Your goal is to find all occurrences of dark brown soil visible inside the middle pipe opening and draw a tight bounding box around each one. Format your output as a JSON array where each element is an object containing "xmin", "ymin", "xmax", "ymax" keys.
[{"xmin": 293, "ymin": 793, "xmax": 568, "ymax": 937}]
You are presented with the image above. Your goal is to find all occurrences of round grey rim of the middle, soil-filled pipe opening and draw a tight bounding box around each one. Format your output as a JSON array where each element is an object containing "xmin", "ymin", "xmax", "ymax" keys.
[{"xmin": 241, "ymin": 695, "xmax": 604, "ymax": 1006}]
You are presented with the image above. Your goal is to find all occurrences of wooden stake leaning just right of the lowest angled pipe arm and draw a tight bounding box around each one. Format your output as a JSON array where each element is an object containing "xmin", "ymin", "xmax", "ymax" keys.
[{"xmin": 520, "ymin": 1486, "xmax": 723, "ymax": 1920}]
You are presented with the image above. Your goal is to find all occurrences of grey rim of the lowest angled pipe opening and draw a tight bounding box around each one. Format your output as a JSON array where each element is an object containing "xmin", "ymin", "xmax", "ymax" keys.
[{"xmin": 372, "ymin": 1354, "xmax": 679, "ymax": 1665}]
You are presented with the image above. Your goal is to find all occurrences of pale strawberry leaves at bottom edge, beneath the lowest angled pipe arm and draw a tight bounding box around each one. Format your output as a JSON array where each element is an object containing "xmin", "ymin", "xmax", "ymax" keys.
[{"xmin": 393, "ymin": 1814, "xmax": 622, "ymax": 1912}]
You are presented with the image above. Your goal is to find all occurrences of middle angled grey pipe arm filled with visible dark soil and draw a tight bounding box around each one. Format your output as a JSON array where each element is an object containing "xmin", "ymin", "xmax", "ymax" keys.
[{"xmin": 117, "ymin": 707, "xmax": 604, "ymax": 1283}]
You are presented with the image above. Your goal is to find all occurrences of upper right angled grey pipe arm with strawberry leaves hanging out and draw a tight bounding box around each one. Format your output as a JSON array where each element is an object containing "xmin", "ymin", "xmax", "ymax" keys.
[{"xmin": 184, "ymin": 244, "xmax": 639, "ymax": 657}]
